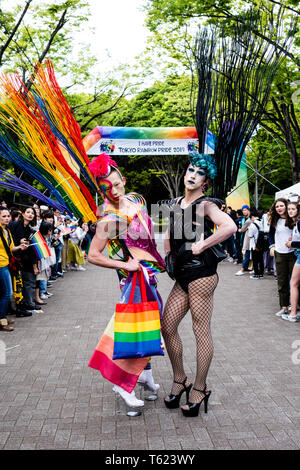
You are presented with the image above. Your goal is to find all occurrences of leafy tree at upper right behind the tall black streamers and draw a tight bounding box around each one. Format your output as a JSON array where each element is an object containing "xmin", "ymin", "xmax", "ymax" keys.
[{"xmin": 146, "ymin": 0, "xmax": 300, "ymax": 183}]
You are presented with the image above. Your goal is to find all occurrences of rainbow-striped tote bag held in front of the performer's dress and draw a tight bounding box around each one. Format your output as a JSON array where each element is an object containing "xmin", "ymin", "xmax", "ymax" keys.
[{"xmin": 113, "ymin": 272, "xmax": 164, "ymax": 359}]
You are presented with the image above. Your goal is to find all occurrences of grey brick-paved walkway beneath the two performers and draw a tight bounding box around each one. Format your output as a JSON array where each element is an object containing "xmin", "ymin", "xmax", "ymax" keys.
[{"xmin": 0, "ymin": 248, "xmax": 300, "ymax": 450}]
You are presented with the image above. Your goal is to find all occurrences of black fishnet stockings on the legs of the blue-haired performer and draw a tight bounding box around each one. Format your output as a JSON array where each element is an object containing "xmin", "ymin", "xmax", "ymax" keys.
[{"xmin": 162, "ymin": 274, "xmax": 218, "ymax": 403}]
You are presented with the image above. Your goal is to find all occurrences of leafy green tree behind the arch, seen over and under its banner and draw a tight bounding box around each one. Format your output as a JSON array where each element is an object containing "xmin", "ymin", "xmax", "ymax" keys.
[{"xmin": 102, "ymin": 76, "xmax": 193, "ymax": 200}]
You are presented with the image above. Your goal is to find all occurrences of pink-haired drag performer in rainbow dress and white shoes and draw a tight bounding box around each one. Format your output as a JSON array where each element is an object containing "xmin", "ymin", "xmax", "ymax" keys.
[{"xmin": 88, "ymin": 154, "xmax": 165, "ymax": 407}]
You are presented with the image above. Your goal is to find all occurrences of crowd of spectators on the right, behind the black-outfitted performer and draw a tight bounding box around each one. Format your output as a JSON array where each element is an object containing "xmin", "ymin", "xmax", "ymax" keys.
[{"xmin": 222, "ymin": 195, "xmax": 300, "ymax": 323}]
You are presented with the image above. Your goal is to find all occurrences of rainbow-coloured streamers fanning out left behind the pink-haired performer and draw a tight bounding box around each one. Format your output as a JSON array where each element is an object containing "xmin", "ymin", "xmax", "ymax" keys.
[{"xmin": 0, "ymin": 64, "xmax": 97, "ymax": 222}]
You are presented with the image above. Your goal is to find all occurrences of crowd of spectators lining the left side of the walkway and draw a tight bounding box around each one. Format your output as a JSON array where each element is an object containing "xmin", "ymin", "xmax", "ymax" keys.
[{"xmin": 0, "ymin": 201, "xmax": 94, "ymax": 331}]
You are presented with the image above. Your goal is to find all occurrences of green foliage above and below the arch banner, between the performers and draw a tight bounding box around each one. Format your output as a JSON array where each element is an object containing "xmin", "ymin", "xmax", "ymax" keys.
[{"xmin": 97, "ymin": 76, "xmax": 193, "ymax": 203}]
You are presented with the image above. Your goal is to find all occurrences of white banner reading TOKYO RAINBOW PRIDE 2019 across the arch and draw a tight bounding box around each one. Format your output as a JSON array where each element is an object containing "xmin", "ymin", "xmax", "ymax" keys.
[{"xmin": 87, "ymin": 139, "xmax": 213, "ymax": 155}]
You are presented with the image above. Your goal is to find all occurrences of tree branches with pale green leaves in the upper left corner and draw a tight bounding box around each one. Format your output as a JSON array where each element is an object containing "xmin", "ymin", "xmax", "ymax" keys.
[{"xmin": 0, "ymin": 0, "xmax": 95, "ymax": 87}]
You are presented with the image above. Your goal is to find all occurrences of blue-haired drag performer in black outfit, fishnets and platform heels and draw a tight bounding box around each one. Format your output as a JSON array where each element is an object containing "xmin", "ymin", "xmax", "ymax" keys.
[{"xmin": 162, "ymin": 154, "xmax": 236, "ymax": 416}]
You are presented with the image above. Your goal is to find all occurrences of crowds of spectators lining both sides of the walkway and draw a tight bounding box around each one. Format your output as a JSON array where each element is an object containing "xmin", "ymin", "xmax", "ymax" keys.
[{"xmin": 0, "ymin": 197, "xmax": 300, "ymax": 331}]
